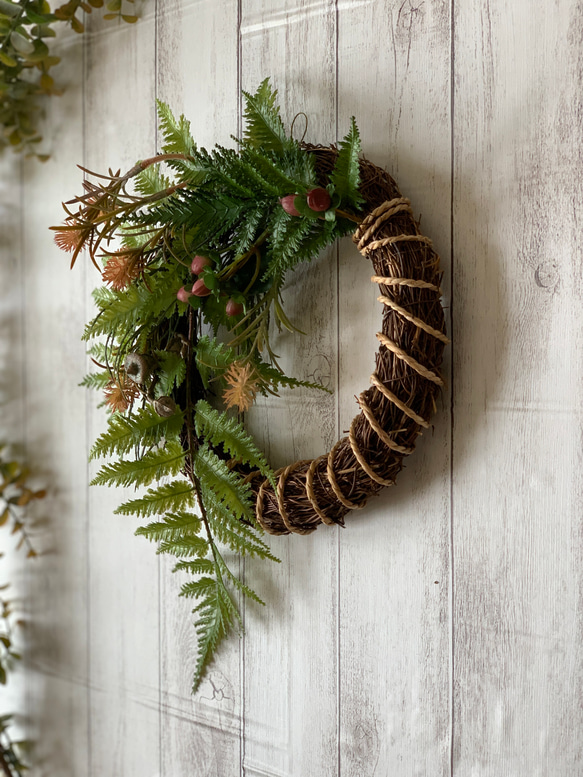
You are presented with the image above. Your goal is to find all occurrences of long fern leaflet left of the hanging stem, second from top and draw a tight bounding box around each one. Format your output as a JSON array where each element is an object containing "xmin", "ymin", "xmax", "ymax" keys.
[{"xmin": 90, "ymin": 442, "xmax": 186, "ymax": 486}]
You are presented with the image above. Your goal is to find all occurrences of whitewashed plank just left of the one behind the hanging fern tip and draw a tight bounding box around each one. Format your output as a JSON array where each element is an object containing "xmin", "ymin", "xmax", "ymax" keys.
[{"xmin": 83, "ymin": 9, "xmax": 160, "ymax": 777}]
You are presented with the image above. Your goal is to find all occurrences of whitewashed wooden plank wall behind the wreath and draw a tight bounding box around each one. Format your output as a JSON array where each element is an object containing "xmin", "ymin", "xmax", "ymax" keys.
[{"xmin": 0, "ymin": 0, "xmax": 583, "ymax": 777}]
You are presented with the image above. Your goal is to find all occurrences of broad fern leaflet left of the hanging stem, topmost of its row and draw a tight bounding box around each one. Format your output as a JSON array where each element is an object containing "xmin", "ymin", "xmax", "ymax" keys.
[{"xmin": 89, "ymin": 405, "xmax": 184, "ymax": 460}]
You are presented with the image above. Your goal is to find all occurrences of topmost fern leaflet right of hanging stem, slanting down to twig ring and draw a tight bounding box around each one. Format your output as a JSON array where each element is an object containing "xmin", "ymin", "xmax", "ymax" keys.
[{"xmin": 194, "ymin": 399, "xmax": 275, "ymax": 488}]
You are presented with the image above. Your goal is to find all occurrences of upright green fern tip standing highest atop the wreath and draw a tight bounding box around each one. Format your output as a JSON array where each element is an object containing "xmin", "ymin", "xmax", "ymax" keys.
[{"xmin": 243, "ymin": 78, "xmax": 293, "ymax": 154}]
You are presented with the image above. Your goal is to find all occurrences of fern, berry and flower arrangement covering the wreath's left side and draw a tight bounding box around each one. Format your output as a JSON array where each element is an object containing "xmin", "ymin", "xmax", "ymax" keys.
[{"xmin": 54, "ymin": 80, "xmax": 362, "ymax": 690}]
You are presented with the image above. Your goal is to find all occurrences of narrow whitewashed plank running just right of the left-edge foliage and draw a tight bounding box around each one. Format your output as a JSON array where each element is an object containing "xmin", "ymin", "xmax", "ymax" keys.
[{"xmin": 18, "ymin": 31, "xmax": 88, "ymax": 775}]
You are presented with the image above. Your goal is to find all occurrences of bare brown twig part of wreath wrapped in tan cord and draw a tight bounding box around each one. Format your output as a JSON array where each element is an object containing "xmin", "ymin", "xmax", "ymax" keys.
[{"xmin": 249, "ymin": 147, "xmax": 447, "ymax": 534}]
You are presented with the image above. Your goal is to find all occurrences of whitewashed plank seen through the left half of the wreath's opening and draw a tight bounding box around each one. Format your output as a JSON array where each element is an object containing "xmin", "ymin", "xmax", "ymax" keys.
[{"xmin": 241, "ymin": 0, "xmax": 338, "ymax": 776}]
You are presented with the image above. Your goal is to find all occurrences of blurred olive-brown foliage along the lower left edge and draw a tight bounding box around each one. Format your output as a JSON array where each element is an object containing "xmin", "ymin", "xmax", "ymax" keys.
[{"xmin": 0, "ymin": 448, "xmax": 46, "ymax": 777}]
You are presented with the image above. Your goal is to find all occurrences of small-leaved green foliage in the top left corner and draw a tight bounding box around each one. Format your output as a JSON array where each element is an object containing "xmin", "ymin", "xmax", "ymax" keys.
[{"xmin": 0, "ymin": 0, "xmax": 137, "ymax": 161}]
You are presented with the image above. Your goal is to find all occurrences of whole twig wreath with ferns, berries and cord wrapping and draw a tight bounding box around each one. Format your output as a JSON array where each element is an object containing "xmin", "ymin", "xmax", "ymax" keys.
[{"xmin": 53, "ymin": 80, "xmax": 447, "ymax": 690}]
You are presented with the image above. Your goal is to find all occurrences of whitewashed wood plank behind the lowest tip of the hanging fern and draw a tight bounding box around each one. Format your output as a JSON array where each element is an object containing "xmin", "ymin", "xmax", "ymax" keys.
[{"xmin": 157, "ymin": 0, "xmax": 241, "ymax": 777}]
